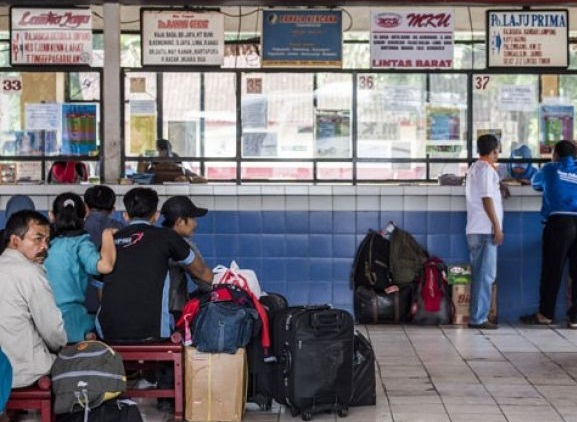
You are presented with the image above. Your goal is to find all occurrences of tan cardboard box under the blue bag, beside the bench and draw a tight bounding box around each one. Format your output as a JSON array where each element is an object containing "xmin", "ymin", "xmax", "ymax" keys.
[{"xmin": 184, "ymin": 347, "xmax": 248, "ymax": 422}]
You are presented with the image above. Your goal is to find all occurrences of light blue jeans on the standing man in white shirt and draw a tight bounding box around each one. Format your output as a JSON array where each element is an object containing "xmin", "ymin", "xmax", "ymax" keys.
[{"xmin": 467, "ymin": 234, "xmax": 497, "ymax": 324}]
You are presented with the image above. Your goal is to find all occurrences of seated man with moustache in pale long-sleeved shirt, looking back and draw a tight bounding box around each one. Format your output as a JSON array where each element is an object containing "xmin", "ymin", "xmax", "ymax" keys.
[{"xmin": 0, "ymin": 210, "xmax": 67, "ymax": 388}]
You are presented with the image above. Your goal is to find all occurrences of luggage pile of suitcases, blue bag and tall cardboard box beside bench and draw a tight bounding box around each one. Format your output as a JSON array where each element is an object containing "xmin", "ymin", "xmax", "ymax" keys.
[{"xmin": 178, "ymin": 265, "xmax": 376, "ymax": 422}]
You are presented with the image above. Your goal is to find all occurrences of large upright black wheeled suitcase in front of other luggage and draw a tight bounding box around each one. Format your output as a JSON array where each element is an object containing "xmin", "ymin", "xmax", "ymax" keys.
[{"xmin": 273, "ymin": 305, "xmax": 354, "ymax": 421}]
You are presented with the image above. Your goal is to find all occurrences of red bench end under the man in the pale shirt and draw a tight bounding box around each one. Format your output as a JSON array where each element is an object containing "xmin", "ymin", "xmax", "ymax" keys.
[{"xmin": 6, "ymin": 376, "xmax": 55, "ymax": 422}]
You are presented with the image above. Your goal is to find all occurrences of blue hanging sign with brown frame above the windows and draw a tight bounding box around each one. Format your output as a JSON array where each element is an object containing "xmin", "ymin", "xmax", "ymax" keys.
[{"xmin": 261, "ymin": 10, "xmax": 343, "ymax": 68}]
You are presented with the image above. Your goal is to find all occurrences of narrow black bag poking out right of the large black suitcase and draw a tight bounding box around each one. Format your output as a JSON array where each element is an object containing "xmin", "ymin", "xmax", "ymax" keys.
[{"xmin": 349, "ymin": 331, "xmax": 377, "ymax": 407}]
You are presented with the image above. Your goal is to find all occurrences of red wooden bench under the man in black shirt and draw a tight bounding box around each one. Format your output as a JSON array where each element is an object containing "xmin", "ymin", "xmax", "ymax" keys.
[{"xmin": 109, "ymin": 342, "xmax": 184, "ymax": 422}]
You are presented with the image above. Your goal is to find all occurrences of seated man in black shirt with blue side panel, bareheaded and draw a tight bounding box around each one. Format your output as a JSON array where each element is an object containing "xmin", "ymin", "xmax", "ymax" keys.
[{"xmin": 96, "ymin": 187, "xmax": 213, "ymax": 342}]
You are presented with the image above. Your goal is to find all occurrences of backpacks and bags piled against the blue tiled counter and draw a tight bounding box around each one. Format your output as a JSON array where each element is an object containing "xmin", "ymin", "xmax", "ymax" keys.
[{"xmin": 350, "ymin": 222, "xmax": 454, "ymax": 325}]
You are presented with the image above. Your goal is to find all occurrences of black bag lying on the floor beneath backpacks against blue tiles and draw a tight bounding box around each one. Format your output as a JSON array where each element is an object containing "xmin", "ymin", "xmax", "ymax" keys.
[{"xmin": 354, "ymin": 285, "xmax": 413, "ymax": 324}]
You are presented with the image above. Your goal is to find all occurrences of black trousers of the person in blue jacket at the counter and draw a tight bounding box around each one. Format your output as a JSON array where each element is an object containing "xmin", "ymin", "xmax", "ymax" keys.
[{"xmin": 539, "ymin": 214, "xmax": 577, "ymax": 320}]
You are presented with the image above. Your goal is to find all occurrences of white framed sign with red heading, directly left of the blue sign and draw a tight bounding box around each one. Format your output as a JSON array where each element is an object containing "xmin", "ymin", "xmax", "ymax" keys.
[{"xmin": 140, "ymin": 9, "xmax": 224, "ymax": 66}]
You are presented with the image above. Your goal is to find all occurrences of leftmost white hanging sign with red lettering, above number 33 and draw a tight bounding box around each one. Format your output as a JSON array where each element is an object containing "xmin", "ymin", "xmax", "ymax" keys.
[{"xmin": 10, "ymin": 7, "xmax": 92, "ymax": 66}]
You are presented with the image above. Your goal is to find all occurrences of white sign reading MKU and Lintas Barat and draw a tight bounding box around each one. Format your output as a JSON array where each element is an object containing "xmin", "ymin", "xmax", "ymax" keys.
[{"xmin": 371, "ymin": 10, "xmax": 455, "ymax": 69}]
